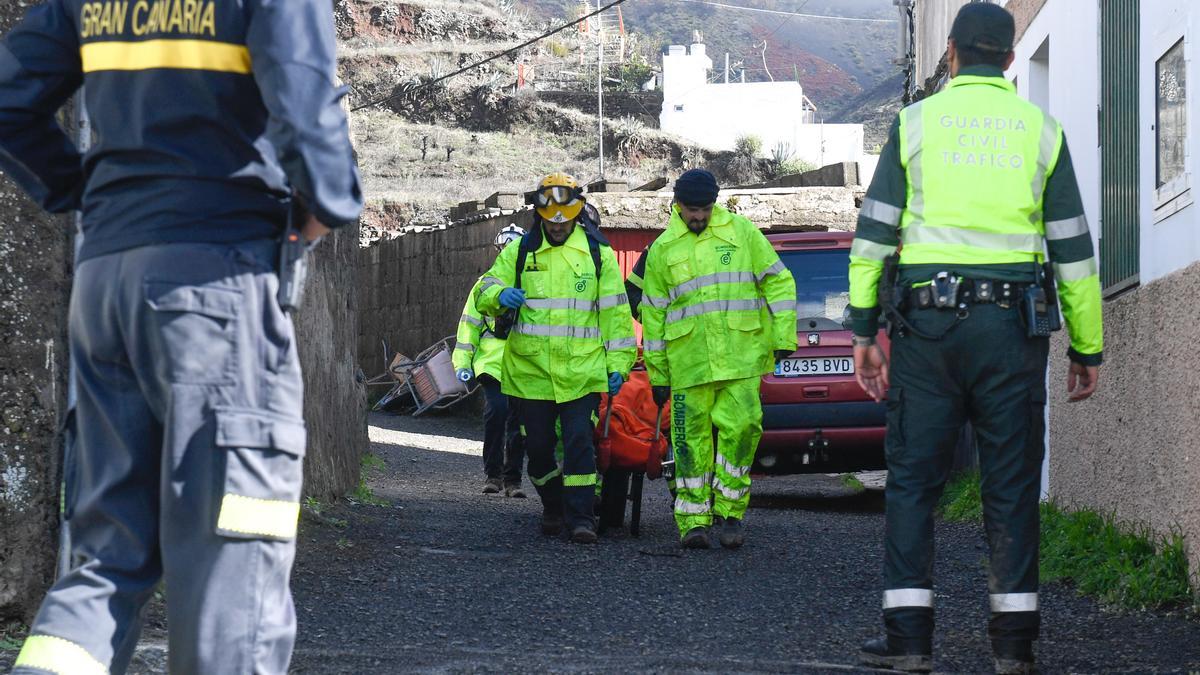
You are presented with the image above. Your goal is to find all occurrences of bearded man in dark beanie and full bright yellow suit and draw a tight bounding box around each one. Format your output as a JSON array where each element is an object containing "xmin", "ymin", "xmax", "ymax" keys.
[{"xmin": 641, "ymin": 169, "xmax": 796, "ymax": 549}]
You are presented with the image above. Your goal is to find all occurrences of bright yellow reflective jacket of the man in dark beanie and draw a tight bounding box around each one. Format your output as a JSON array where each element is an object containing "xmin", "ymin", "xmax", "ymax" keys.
[{"xmin": 641, "ymin": 205, "xmax": 796, "ymax": 388}]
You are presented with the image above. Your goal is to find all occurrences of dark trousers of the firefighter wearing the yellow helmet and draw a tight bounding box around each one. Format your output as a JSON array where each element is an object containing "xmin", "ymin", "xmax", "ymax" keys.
[{"xmin": 523, "ymin": 394, "xmax": 600, "ymax": 528}]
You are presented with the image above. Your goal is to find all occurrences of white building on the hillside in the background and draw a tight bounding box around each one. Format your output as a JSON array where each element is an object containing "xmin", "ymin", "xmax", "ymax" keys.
[{"xmin": 660, "ymin": 43, "xmax": 863, "ymax": 167}]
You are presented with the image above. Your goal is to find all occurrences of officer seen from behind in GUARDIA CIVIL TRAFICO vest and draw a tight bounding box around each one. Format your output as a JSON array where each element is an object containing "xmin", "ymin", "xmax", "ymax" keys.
[{"xmin": 850, "ymin": 2, "xmax": 1103, "ymax": 673}]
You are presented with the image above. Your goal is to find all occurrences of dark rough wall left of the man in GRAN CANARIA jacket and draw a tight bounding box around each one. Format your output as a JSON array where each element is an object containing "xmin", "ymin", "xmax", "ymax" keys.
[{"xmin": 0, "ymin": 2, "xmax": 73, "ymax": 620}]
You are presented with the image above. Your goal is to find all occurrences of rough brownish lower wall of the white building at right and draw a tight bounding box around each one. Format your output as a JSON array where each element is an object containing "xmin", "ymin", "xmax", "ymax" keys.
[{"xmin": 1050, "ymin": 255, "xmax": 1200, "ymax": 583}]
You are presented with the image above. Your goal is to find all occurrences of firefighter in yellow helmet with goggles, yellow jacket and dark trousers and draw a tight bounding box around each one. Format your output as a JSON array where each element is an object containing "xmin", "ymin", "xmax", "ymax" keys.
[{"xmin": 476, "ymin": 173, "xmax": 637, "ymax": 543}]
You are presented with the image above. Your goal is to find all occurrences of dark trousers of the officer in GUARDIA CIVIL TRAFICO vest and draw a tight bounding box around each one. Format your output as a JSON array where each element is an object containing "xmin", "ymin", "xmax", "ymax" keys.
[{"xmin": 883, "ymin": 304, "xmax": 1049, "ymax": 650}]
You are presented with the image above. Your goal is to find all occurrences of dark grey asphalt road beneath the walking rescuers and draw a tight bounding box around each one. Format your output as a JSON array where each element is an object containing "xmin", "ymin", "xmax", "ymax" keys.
[{"xmin": 11, "ymin": 408, "xmax": 1200, "ymax": 674}]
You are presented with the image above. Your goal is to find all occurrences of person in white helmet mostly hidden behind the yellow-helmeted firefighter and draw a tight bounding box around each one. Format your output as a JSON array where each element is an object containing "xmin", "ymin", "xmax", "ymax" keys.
[{"xmin": 450, "ymin": 225, "xmax": 526, "ymax": 498}]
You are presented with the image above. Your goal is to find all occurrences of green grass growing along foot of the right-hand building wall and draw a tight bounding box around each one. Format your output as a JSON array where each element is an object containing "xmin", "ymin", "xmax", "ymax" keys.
[{"xmin": 938, "ymin": 472, "xmax": 1194, "ymax": 609}]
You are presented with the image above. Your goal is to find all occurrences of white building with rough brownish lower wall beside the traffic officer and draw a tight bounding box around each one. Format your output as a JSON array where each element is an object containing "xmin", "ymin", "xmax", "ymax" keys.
[{"xmin": 998, "ymin": 0, "xmax": 1200, "ymax": 574}]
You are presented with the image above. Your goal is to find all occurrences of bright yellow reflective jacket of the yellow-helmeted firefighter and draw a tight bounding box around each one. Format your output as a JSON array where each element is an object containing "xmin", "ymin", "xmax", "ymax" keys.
[{"xmin": 476, "ymin": 226, "xmax": 637, "ymax": 402}]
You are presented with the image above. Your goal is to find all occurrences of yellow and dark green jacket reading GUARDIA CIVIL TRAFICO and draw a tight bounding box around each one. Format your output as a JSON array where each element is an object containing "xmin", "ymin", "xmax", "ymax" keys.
[{"xmin": 850, "ymin": 70, "xmax": 1104, "ymax": 360}]
